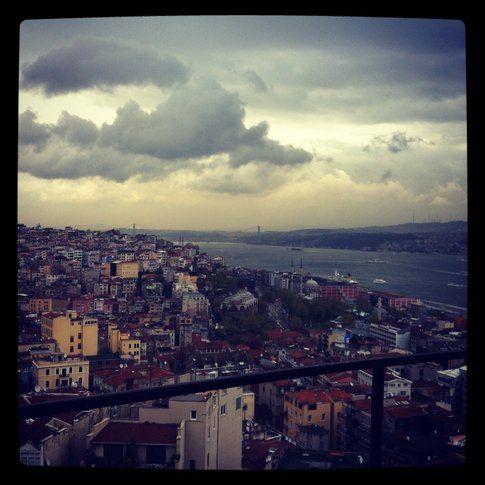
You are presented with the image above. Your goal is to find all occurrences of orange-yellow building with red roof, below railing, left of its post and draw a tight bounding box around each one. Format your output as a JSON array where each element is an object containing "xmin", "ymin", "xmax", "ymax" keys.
[{"xmin": 284, "ymin": 389, "xmax": 352, "ymax": 449}]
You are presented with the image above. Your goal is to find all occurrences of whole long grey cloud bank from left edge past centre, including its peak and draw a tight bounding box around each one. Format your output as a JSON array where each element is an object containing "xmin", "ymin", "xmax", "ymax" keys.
[{"xmin": 19, "ymin": 79, "xmax": 312, "ymax": 181}]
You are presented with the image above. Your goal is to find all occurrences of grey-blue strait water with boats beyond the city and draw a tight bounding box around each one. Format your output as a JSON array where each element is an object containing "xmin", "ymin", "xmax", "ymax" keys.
[{"xmin": 196, "ymin": 242, "xmax": 468, "ymax": 308}]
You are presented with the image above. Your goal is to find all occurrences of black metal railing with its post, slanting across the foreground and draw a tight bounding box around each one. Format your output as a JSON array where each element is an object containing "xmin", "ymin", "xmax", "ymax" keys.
[{"xmin": 19, "ymin": 350, "xmax": 467, "ymax": 467}]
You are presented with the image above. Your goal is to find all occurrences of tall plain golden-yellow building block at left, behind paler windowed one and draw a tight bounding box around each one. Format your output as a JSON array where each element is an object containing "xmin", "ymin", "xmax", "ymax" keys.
[{"xmin": 41, "ymin": 310, "xmax": 98, "ymax": 356}]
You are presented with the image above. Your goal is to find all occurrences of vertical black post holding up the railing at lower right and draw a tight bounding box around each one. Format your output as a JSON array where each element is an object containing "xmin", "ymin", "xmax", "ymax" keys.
[{"xmin": 369, "ymin": 365, "xmax": 385, "ymax": 467}]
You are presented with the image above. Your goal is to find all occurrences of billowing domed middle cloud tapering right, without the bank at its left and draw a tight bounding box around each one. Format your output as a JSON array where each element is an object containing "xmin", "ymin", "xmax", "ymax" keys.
[{"xmin": 100, "ymin": 79, "xmax": 311, "ymax": 166}]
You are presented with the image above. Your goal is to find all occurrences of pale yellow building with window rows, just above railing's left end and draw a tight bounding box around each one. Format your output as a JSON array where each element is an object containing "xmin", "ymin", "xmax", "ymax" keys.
[{"xmin": 32, "ymin": 357, "xmax": 89, "ymax": 391}]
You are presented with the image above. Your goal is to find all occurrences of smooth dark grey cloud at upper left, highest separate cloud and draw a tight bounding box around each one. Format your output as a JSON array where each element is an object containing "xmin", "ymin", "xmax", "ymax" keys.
[{"xmin": 20, "ymin": 38, "xmax": 187, "ymax": 95}]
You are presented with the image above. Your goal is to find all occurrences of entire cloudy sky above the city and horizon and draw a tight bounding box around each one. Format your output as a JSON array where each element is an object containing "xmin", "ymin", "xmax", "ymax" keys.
[{"xmin": 18, "ymin": 16, "xmax": 467, "ymax": 230}]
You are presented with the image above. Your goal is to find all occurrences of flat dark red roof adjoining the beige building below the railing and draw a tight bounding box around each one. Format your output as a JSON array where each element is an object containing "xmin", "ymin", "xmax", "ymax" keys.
[{"xmin": 91, "ymin": 421, "xmax": 179, "ymax": 445}]
